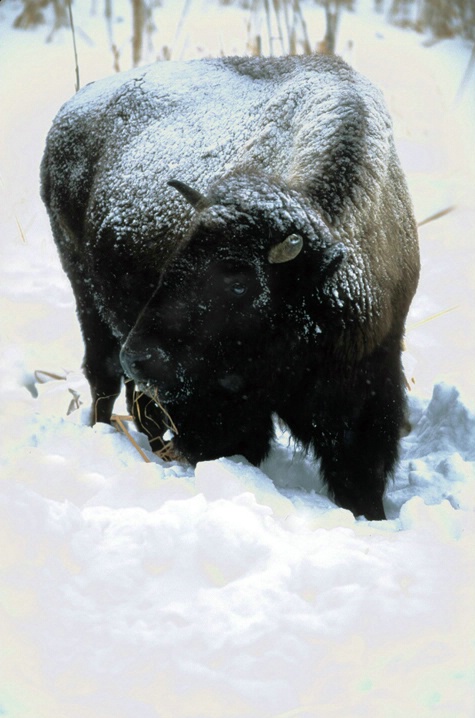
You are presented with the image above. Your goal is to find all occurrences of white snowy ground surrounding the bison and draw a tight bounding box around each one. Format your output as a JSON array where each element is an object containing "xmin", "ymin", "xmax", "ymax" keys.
[{"xmin": 0, "ymin": 0, "xmax": 475, "ymax": 718}]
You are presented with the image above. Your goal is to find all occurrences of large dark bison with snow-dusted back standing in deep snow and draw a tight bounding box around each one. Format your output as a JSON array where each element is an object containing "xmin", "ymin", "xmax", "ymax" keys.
[{"xmin": 42, "ymin": 56, "xmax": 419, "ymax": 519}]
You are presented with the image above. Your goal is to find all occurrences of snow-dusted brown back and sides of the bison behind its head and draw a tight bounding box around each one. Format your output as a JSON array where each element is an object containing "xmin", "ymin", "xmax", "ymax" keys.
[{"xmin": 43, "ymin": 55, "xmax": 418, "ymax": 355}]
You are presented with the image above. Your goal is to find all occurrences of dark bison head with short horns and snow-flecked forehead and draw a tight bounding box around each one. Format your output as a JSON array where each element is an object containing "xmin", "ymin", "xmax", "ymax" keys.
[{"xmin": 121, "ymin": 175, "xmax": 345, "ymax": 403}]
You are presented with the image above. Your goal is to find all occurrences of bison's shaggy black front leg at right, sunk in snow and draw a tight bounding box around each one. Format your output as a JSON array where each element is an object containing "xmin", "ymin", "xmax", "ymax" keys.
[{"xmin": 312, "ymin": 352, "xmax": 405, "ymax": 520}]
